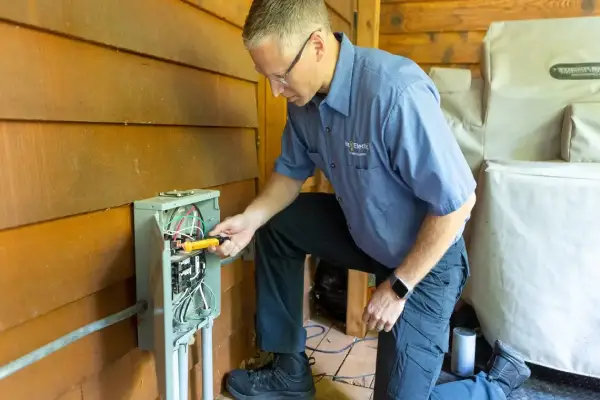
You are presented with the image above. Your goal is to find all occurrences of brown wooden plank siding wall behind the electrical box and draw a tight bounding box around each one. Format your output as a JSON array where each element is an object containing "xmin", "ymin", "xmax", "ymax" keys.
[{"xmin": 0, "ymin": 0, "xmax": 267, "ymax": 400}]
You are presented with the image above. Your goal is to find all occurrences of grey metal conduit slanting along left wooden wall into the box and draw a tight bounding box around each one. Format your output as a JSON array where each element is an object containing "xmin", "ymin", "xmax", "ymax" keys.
[{"xmin": 0, "ymin": 301, "xmax": 148, "ymax": 380}]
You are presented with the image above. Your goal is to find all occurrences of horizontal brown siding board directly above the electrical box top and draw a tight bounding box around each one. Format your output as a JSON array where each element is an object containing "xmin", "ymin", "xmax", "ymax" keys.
[{"xmin": 0, "ymin": 122, "xmax": 258, "ymax": 229}]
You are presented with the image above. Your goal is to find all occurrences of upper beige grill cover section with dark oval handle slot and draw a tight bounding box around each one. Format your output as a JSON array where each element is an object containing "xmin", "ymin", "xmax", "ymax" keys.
[{"xmin": 482, "ymin": 17, "xmax": 600, "ymax": 161}]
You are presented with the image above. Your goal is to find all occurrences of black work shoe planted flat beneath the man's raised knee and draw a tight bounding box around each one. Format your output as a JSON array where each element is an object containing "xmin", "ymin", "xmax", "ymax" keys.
[{"xmin": 226, "ymin": 353, "xmax": 316, "ymax": 400}]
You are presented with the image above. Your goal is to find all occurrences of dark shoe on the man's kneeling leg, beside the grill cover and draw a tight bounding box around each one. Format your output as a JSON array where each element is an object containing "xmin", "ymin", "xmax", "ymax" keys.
[{"xmin": 486, "ymin": 340, "xmax": 531, "ymax": 397}]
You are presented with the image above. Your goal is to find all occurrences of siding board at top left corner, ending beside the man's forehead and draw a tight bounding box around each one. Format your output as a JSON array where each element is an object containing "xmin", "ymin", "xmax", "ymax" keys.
[{"xmin": 0, "ymin": 0, "xmax": 258, "ymax": 82}]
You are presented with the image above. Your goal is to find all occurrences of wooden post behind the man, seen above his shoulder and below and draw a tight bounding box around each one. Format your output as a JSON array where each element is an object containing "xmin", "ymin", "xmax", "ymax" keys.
[{"xmin": 346, "ymin": 0, "xmax": 381, "ymax": 337}]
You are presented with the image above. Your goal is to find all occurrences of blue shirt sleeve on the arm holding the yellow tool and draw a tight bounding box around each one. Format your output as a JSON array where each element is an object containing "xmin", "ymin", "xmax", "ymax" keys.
[{"xmin": 274, "ymin": 114, "xmax": 315, "ymax": 181}]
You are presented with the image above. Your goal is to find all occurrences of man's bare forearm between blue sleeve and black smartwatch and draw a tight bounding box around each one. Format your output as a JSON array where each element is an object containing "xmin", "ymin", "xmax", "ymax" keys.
[{"xmin": 395, "ymin": 194, "xmax": 475, "ymax": 287}]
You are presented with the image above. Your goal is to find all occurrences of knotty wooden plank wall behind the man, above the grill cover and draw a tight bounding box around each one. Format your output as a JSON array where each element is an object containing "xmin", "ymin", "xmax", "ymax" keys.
[{"xmin": 379, "ymin": 0, "xmax": 600, "ymax": 75}]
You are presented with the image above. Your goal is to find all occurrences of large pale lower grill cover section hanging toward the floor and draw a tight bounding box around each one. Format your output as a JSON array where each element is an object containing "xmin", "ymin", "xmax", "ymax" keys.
[{"xmin": 464, "ymin": 161, "xmax": 600, "ymax": 378}]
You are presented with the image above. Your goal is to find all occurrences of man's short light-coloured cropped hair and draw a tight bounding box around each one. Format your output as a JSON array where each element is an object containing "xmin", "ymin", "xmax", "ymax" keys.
[{"xmin": 242, "ymin": 0, "xmax": 331, "ymax": 52}]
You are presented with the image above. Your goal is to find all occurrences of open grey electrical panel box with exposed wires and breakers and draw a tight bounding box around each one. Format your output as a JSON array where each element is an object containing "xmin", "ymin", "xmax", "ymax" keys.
[{"xmin": 133, "ymin": 190, "xmax": 221, "ymax": 400}]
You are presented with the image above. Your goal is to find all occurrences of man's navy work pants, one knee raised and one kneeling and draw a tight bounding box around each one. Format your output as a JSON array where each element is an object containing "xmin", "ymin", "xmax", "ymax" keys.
[{"xmin": 256, "ymin": 193, "xmax": 506, "ymax": 400}]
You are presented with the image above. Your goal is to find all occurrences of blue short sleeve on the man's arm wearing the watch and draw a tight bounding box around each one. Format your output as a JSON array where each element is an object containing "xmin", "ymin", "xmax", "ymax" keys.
[{"xmin": 384, "ymin": 80, "xmax": 476, "ymax": 216}]
